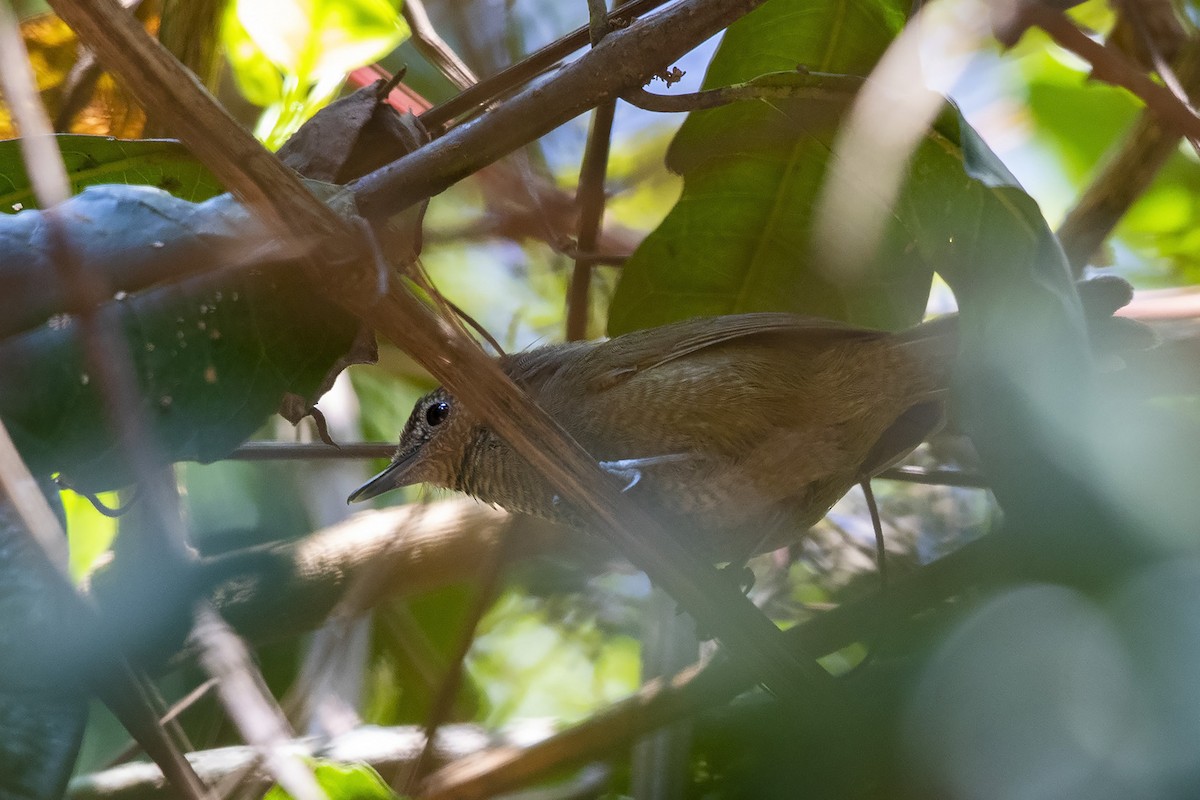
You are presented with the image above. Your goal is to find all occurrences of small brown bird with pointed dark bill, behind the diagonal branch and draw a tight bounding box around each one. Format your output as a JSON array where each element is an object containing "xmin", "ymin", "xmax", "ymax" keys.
[{"xmin": 349, "ymin": 313, "xmax": 958, "ymax": 560}]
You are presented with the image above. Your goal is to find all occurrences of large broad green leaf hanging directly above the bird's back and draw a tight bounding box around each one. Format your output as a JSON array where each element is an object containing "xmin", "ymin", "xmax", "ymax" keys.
[{"xmin": 608, "ymin": 0, "xmax": 937, "ymax": 335}]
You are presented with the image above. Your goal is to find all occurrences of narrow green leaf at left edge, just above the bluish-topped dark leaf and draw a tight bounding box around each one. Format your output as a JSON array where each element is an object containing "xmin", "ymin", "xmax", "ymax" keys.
[{"xmin": 0, "ymin": 134, "xmax": 223, "ymax": 212}]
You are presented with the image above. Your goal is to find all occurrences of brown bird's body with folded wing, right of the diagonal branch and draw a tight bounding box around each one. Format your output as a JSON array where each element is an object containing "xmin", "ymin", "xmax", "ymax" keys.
[{"xmin": 492, "ymin": 313, "xmax": 944, "ymax": 554}]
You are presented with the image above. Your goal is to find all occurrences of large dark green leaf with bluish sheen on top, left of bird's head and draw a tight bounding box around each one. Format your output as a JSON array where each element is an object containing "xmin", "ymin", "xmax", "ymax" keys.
[{"xmin": 0, "ymin": 186, "xmax": 359, "ymax": 491}]
